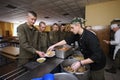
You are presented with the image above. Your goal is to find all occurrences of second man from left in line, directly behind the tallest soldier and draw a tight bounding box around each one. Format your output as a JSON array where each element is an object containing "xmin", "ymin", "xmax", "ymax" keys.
[{"xmin": 39, "ymin": 21, "xmax": 49, "ymax": 52}]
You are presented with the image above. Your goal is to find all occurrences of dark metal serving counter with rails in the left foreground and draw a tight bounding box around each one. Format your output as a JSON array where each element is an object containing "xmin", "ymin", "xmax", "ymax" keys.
[{"xmin": 0, "ymin": 57, "xmax": 63, "ymax": 80}]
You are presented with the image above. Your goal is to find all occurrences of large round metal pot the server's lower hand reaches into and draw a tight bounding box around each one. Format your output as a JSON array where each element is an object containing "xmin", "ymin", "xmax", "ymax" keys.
[{"xmin": 60, "ymin": 59, "xmax": 90, "ymax": 80}]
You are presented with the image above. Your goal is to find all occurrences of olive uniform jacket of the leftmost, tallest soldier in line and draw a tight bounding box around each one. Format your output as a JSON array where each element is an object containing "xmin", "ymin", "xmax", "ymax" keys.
[{"xmin": 17, "ymin": 23, "xmax": 39, "ymax": 58}]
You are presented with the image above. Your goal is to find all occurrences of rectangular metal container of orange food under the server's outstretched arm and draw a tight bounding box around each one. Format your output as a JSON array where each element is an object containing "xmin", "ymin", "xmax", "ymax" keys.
[{"xmin": 55, "ymin": 45, "xmax": 73, "ymax": 59}]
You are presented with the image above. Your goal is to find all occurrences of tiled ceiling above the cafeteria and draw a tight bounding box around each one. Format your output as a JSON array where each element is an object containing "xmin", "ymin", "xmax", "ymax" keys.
[{"xmin": 0, "ymin": 0, "xmax": 110, "ymax": 25}]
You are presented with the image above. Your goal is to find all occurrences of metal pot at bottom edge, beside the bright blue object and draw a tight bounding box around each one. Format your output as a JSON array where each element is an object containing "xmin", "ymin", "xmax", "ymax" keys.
[{"xmin": 54, "ymin": 73, "xmax": 78, "ymax": 80}]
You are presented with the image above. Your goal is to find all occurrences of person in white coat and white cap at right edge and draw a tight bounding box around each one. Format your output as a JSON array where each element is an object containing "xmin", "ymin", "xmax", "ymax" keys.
[{"xmin": 103, "ymin": 24, "xmax": 120, "ymax": 73}]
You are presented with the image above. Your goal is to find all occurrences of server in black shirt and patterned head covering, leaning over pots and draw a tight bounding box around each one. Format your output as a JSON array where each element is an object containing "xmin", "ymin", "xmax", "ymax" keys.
[{"xmin": 48, "ymin": 17, "xmax": 106, "ymax": 80}]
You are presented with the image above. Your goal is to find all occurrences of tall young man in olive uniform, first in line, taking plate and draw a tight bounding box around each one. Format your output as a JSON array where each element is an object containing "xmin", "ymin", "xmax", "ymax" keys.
[{"xmin": 17, "ymin": 11, "xmax": 44, "ymax": 66}]
